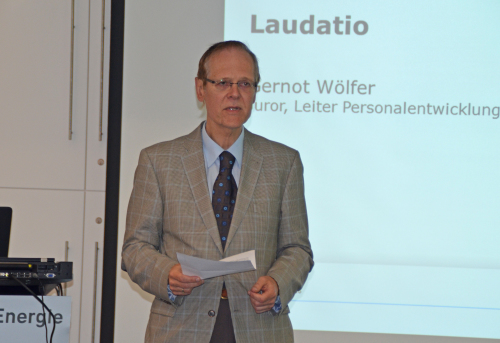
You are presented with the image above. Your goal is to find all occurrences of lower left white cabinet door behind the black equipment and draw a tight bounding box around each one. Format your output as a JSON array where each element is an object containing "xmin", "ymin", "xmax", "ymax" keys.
[{"xmin": 0, "ymin": 188, "xmax": 84, "ymax": 343}]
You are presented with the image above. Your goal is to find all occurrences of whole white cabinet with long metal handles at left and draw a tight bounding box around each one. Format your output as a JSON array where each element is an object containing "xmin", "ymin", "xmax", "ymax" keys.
[{"xmin": 0, "ymin": 0, "xmax": 111, "ymax": 343}]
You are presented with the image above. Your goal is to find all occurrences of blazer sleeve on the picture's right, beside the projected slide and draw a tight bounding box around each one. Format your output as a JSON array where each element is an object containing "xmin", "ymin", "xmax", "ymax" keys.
[{"xmin": 267, "ymin": 152, "xmax": 314, "ymax": 313}]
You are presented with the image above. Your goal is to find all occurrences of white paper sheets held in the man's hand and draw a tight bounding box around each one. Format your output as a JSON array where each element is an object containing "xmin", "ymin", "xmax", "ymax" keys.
[{"xmin": 177, "ymin": 250, "xmax": 256, "ymax": 279}]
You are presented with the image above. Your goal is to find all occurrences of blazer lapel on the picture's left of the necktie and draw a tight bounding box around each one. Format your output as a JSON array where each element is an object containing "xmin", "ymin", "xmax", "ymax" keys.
[{"xmin": 181, "ymin": 126, "xmax": 223, "ymax": 254}]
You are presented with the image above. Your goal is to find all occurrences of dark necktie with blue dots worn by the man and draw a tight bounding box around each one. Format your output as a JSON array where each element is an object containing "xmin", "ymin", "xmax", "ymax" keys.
[{"xmin": 212, "ymin": 151, "xmax": 238, "ymax": 250}]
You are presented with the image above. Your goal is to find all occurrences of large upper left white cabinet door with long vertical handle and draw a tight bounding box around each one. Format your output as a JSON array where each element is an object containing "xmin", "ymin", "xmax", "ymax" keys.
[{"xmin": 0, "ymin": 0, "xmax": 88, "ymax": 189}]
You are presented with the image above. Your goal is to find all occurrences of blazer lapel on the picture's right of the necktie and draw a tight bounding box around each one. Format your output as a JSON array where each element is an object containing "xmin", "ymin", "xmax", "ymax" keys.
[{"xmin": 226, "ymin": 131, "xmax": 263, "ymax": 249}]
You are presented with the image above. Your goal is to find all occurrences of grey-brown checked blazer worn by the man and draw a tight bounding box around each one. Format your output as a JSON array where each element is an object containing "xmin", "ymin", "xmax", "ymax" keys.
[{"xmin": 122, "ymin": 125, "xmax": 313, "ymax": 343}]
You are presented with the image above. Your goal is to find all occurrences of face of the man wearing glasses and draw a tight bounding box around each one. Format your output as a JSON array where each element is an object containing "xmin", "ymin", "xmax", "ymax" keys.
[{"xmin": 196, "ymin": 48, "xmax": 255, "ymax": 134}]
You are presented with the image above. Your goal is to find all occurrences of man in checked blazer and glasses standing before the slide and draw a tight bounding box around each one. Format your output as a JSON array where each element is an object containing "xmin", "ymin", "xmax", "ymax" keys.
[{"xmin": 122, "ymin": 41, "xmax": 313, "ymax": 343}]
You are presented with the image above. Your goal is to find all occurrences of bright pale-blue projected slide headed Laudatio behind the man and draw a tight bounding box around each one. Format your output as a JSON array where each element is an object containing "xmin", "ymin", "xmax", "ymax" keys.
[{"xmin": 228, "ymin": 0, "xmax": 500, "ymax": 338}]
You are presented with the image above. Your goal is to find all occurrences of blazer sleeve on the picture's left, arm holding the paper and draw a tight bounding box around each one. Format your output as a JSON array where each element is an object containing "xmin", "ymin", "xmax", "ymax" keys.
[{"xmin": 122, "ymin": 150, "xmax": 184, "ymax": 306}]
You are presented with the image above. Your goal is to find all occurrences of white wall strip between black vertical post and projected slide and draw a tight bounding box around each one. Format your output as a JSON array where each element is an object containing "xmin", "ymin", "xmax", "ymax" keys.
[{"xmin": 115, "ymin": 0, "xmax": 224, "ymax": 342}]
